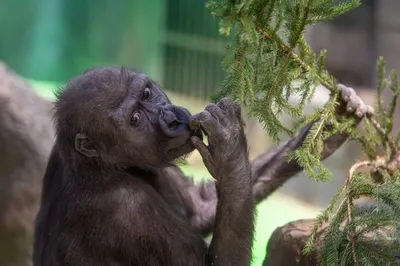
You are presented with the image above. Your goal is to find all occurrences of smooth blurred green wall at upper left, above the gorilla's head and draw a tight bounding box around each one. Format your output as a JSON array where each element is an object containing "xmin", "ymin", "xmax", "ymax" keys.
[{"xmin": 0, "ymin": 0, "xmax": 166, "ymax": 81}]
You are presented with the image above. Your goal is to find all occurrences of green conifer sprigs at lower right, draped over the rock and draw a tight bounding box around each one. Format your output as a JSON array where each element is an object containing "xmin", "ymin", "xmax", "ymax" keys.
[{"xmin": 304, "ymin": 58, "xmax": 400, "ymax": 266}]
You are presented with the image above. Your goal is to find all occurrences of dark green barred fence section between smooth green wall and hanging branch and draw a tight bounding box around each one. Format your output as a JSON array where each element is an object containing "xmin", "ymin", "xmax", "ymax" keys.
[{"xmin": 163, "ymin": 0, "xmax": 229, "ymax": 98}]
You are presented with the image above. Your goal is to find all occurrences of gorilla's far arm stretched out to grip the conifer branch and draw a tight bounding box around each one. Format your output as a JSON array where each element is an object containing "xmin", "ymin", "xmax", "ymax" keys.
[{"xmin": 173, "ymin": 85, "xmax": 373, "ymax": 235}]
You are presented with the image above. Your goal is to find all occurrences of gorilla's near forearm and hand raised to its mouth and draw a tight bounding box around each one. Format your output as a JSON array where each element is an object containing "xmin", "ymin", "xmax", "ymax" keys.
[{"xmin": 189, "ymin": 98, "xmax": 255, "ymax": 265}]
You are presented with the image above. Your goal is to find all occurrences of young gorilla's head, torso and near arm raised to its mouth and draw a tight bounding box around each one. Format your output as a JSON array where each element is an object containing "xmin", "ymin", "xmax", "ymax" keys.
[{"xmin": 34, "ymin": 67, "xmax": 254, "ymax": 266}]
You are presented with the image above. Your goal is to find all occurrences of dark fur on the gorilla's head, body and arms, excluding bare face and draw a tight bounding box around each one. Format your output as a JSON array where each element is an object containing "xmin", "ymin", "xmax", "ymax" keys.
[{"xmin": 34, "ymin": 68, "xmax": 366, "ymax": 266}]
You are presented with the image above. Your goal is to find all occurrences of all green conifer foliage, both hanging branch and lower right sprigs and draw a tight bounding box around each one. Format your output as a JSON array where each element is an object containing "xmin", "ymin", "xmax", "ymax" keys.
[{"xmin": 207, "ymin": 0, "xmax": 400, "ymax": 266}]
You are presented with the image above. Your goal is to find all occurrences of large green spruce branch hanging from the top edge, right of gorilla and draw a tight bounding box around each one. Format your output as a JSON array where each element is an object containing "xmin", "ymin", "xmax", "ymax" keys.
[{"xmin": 207, "ymin": 0, "xmax": 360, "ymax": 180}]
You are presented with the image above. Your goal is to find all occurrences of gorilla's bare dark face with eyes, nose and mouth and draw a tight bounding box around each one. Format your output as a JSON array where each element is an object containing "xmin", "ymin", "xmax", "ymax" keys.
[{"xmin": 121, "ymin": 74, "xmax": 202, "ymax": 161}]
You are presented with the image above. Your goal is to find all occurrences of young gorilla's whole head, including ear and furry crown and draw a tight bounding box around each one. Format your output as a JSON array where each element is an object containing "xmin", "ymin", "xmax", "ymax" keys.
[{"xmin": 56, "ymin": 67, "xmax": 202, "ymax": 168}]
